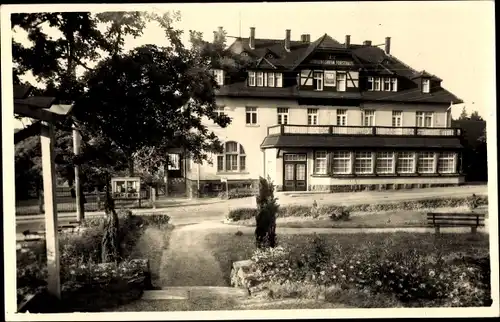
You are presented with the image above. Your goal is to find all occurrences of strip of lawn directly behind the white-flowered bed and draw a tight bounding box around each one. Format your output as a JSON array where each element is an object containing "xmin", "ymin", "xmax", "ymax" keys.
[{"xmin": 206, "ymin": 232, "xmax": 489, "ymax": 300}]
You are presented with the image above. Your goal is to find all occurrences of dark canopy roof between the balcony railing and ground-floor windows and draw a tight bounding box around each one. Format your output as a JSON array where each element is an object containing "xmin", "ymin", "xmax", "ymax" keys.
[{"xmin": 261, "ymin": 135, "xmax": 463, "ymax": 149}]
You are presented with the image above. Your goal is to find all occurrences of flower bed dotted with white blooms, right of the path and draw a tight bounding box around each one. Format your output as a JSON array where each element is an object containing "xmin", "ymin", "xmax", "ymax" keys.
[{"xmin": 209, "ymin": 233, "xmax": 491, "ymax": 307}]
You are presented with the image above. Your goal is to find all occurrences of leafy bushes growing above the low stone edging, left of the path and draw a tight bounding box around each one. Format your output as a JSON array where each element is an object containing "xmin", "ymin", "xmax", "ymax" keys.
[{"xmin": 16, "ymin": 210, "xmax": 161, "ymax": 308}]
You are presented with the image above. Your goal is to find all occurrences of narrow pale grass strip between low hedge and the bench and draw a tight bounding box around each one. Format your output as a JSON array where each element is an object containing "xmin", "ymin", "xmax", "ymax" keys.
[{"xmin": 230, "ymin": 207, "xmax": 488, "ymax": 228}]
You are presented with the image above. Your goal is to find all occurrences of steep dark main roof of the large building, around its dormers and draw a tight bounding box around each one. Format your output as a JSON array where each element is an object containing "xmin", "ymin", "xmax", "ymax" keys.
[{"xmin": 225, "ymin": 34, "xmax": 463, "ymax": 104}]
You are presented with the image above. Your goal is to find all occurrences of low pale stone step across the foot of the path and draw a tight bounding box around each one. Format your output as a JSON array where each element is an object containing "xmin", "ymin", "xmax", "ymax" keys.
[{"xmin": 141, "ymin": 286, "xmax": 248, "ymax": 300}]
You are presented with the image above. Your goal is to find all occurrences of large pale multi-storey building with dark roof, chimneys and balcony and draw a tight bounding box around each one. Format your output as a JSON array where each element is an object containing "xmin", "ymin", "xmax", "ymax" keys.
[{"xmin": 183, "ymin": 28, "xmax": 464, "ymax": 191}]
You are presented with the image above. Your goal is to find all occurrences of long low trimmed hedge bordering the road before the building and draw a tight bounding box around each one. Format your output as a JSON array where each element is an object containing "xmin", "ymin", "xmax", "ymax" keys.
[{"xmin": 227, "ymin": 196, "xmax": 488, "ymax": 221}]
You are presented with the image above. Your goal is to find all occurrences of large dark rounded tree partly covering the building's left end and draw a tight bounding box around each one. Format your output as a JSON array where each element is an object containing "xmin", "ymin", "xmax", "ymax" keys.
[{"xmin": 75, "ymin": 14, "xmax": 244, "ymax": 179}]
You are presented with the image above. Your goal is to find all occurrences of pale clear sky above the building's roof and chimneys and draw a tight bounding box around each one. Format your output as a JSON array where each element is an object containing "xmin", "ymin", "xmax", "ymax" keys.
[{"xmin": 7, "ymin": 1, "xmax": 496, "ymax": 127}]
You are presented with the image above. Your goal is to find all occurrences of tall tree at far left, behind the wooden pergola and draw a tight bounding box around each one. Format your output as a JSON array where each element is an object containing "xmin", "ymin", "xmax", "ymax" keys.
[{"xmin": 11, "ymin": 12, "xmax": 146, "ymax": 184}]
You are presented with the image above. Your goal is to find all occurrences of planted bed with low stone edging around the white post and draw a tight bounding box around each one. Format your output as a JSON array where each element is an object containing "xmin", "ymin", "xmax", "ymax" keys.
[{"xmin": 17, "ymin": 211, "xmax": 169, "ymax": 311}]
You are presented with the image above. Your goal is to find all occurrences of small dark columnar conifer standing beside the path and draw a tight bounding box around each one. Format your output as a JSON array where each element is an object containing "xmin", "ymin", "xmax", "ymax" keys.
[{"xmin": 255, "ymin": 177, "xmax": 279, "ymax": 248}]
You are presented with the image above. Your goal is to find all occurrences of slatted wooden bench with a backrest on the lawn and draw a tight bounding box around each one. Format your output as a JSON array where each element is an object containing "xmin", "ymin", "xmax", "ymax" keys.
[{"xmin": 427, "ymin": 212, "xmax": 485, "ymax": 234}]
